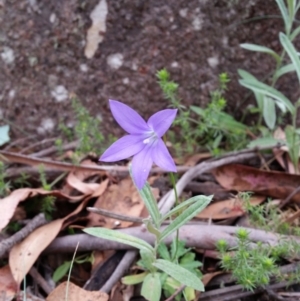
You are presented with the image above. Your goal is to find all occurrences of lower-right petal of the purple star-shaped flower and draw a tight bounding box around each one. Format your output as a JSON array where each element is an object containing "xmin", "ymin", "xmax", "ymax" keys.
[{"xmin": 151, "ymin": 139, "xmax": 177, "ymax": 172}]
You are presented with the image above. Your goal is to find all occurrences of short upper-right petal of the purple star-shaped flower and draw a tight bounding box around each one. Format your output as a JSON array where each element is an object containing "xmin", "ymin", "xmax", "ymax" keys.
[{"xmin": 147, "ymin": 109, "xmax": 177, "ymax": 137}]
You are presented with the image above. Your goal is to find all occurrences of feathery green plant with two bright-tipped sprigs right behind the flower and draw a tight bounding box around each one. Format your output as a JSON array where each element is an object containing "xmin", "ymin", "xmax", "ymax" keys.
[{"xmin": 156, "ymin": 69, "xmax": 248, "ymax": 155}]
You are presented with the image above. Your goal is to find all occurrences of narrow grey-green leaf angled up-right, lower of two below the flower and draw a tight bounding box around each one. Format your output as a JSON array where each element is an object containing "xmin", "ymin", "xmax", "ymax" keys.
[{"xmin": 160, "ymin": 195, "xmax": 212, "ymax": 241}]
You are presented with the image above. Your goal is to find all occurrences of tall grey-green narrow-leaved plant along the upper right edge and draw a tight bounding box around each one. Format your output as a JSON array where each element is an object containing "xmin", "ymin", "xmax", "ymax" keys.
[{"xmin": 238, "ymin": 0, "xmax": 300, "ymax": 173}]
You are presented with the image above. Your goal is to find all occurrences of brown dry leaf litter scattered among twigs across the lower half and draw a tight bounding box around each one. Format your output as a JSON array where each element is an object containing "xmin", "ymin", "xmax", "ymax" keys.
[{"xmin": 0, "ymin": 137, "xmax": 300, "ymax": 301}]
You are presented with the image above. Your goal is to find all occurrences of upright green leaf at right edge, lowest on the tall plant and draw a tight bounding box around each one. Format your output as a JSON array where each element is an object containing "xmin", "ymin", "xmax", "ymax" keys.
[{"xmin": 285, "ymin": 125, "xmax": 300, "ymax": 173}]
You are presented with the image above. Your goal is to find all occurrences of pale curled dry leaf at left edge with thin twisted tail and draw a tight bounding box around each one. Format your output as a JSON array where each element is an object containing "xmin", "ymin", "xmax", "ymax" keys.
[{"xmin": 0, "ymin": 188, "xmax": 82, "ymax": 231}]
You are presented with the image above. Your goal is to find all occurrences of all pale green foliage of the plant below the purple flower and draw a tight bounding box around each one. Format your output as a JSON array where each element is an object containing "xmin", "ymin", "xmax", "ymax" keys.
[{"xmin": 84, "ymin": 173, "xmax": 211, "ymax": 301}]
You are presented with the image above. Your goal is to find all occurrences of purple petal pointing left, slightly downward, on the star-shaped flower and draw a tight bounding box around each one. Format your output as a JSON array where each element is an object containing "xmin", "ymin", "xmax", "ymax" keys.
[{"xmin": 99, "ymin": 135, "xmax": 145, "ymax": 162}]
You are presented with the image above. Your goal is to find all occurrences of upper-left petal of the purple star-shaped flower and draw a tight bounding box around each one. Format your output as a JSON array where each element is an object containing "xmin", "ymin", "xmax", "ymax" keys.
[{"xmin": 109, "ymin": 100, "xmax": 149, "ymax": 134}]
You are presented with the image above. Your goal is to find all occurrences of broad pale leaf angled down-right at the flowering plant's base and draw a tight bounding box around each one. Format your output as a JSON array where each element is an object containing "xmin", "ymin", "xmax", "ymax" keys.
[{"xmin": 153, "ymin": 259, "xmax": 204, "ymax": 292}]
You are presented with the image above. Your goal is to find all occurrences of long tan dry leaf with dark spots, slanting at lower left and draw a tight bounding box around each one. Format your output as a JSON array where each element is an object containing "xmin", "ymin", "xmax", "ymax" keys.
[{"xmin": 9, "ymin": 199, "xmax": 89, "ymax": 284}]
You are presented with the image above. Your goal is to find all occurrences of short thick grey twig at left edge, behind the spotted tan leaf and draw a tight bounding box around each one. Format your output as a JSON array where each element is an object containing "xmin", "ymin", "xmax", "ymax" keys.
[{"xmin": 0, "ymin": 213, "xmax": 47, "ymax": 258}]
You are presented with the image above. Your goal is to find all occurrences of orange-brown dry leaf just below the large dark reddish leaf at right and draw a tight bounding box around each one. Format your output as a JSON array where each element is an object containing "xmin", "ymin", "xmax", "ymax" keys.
[{"xmin": 196, "ymin": 196, "xmax": 266, "ymax": 219}]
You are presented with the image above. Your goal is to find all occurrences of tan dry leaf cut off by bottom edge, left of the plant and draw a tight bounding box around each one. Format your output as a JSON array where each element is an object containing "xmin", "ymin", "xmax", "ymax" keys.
[{"xmin": 46, "ymin": 282, "xmax": 108, "ymax": 301}]
